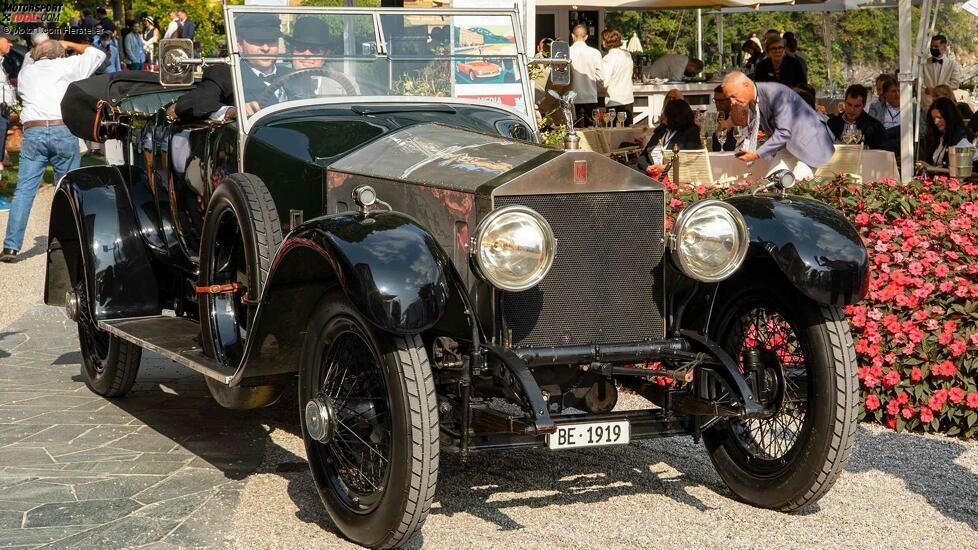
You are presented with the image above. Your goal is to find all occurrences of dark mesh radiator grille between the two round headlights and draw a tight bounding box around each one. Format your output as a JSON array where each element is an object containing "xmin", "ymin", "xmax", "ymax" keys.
[{"xmin": 495, "ymin": 191, "xmax": 665, "ymax": 347}]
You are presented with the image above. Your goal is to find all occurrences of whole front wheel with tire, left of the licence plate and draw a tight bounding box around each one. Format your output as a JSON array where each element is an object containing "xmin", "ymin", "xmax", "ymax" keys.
[{"xmin": 299, "ymin": 292, "xmax": 439, "ymax": 548}]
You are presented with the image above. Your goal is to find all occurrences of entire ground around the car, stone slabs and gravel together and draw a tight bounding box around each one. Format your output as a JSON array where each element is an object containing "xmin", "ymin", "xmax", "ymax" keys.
[{"xmin": 0, "ymin": 305, "xmax": 978, "ymax": 550}]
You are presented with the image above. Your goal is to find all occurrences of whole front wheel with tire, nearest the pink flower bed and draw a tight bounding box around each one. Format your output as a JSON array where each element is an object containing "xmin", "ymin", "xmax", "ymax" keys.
[{"xmin": 703, "ymin": 280, "xmax": 859, "ymax": 512}]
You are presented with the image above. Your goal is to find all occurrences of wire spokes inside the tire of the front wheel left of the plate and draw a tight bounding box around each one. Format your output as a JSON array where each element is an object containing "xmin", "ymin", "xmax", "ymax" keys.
[{"xmin": 315, "ymin": 319, "xmax": 392, "ymax": 513}]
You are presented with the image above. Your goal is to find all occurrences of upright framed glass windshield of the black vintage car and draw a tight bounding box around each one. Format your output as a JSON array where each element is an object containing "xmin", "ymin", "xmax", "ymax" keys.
[{"xmin": 228, "ymin": 8, "xmax": 531, "ymax": 124}]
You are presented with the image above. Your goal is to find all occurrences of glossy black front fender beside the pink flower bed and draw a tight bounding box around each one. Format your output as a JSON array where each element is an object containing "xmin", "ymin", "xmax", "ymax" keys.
[{"xmin": 726, "ymin": 195, "xmax": 869, "ymax": 306}]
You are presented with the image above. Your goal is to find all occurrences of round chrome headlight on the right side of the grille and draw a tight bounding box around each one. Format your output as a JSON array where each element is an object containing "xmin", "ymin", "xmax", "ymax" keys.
[{"xmin": 670, "ymin": 200, "xmax": 748, "ymax": 283}]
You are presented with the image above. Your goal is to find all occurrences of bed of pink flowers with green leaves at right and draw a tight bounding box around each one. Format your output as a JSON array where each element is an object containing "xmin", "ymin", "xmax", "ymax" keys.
[{"xmin": 666, "ymin": 178, "xmax": 978, "ymax": 437}]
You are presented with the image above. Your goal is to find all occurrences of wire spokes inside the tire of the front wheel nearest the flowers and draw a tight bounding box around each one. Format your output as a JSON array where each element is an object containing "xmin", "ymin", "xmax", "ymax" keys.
[{"xmin": 724, "ymin": 305, "xmax": 809, "ymax": 461}]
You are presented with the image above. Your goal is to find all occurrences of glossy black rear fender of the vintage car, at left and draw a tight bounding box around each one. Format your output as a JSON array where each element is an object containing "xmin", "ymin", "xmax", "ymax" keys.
[{"xmin": 44, "ymin": 166, "xmax": 161, "ymax": 320}]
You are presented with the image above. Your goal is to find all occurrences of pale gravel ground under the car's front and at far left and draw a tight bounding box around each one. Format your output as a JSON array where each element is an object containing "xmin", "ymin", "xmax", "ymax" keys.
[{"xmin": 0, "ymin": 180, "xmax": 978, "ymax": 549}]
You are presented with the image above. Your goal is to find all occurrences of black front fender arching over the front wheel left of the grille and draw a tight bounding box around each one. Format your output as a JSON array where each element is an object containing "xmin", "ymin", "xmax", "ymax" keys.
[{"xmin": 231, "ymin": 212, "xmax": 470, "ymax": 385}]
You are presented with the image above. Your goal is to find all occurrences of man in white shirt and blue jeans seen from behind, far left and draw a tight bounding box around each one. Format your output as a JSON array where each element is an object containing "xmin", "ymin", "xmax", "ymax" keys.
[{"xmin": 0, "ymin": 40, "xmax": 105, "ymax": 262}]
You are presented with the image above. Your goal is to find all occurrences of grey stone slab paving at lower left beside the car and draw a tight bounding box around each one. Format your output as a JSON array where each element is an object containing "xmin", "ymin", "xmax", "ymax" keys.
[{"xmin": 0, "ymin": 306, "xmax": 276, "ymax": 548}]
